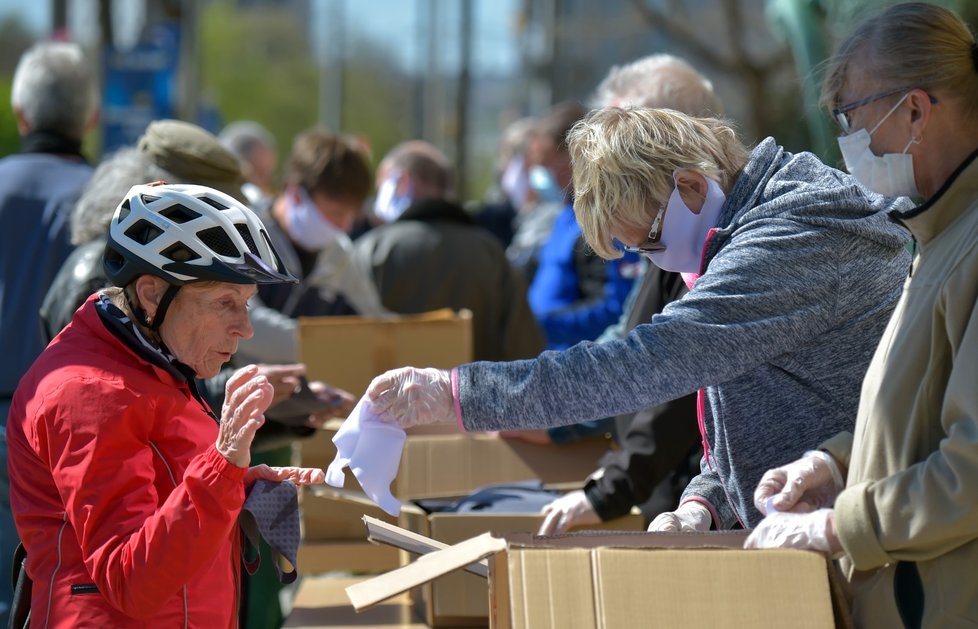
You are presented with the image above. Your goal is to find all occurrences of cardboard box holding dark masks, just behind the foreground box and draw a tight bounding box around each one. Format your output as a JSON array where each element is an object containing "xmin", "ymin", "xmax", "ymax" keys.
[{"xmin": 398, "ymin": 500, "xmax": 645, "ymax": 627}]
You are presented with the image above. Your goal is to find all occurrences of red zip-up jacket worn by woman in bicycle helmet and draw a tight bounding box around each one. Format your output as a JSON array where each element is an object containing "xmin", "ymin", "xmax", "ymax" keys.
[{"xmin": 7, "ymin": 299, "xmax": 247, "ymax": 629}]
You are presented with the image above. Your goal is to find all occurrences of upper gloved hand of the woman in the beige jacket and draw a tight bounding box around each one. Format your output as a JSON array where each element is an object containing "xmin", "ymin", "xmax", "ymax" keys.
[{"xmin": 754, "ymin": 450, "xmax": 845, "ymax": 515}]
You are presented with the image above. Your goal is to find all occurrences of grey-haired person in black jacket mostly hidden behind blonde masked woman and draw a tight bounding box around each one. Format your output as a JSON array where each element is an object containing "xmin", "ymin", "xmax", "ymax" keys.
[{"xmin": 539, "ymin": 54, "xmax": 723, "ymax": 535}]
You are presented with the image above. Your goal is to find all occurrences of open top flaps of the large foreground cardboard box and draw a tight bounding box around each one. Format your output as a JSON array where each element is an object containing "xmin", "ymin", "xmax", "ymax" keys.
[{"xmin": 346, "ymin": 516, "xmax": 747, "ymax": 611}]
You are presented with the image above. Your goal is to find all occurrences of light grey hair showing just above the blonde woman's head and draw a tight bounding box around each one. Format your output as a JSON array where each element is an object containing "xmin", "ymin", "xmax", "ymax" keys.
[{"xmin": 591, "ymin": 54, "xmax": 723, "ymax": 117}]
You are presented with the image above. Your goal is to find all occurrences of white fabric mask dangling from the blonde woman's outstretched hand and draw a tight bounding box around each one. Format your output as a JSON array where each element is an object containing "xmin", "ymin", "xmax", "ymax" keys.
[{"xmin": 326, "ymin": 397, "xmax": 407, "ymax": 516}]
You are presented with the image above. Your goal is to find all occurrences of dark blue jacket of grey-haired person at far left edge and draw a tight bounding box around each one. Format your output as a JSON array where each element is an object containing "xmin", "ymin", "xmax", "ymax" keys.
[{"xmin": 0, "ymin": 153, "xmax": 92, "ymax": 400}]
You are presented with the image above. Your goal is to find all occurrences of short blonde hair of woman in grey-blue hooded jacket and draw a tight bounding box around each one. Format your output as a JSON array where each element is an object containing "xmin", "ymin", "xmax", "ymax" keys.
[{"xmin": 567, "ymin": 107, "xmax": 748, "ymax": 260}]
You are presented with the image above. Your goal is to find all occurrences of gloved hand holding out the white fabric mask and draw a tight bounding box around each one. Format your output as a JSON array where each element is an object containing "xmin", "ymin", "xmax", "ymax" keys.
[{"xmin": 366, "ymin": 367, "xmax": 455, "ymax": 428}]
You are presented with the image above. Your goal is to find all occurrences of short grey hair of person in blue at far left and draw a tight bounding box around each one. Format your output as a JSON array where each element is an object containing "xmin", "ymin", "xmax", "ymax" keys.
[{"xmin": 10, "ymin": 42, "xmax": 98, "ymax": 139}]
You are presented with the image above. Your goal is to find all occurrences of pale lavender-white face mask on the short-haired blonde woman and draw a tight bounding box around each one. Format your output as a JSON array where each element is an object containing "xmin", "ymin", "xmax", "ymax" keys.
[{"xmin": 645, "ymin": 174, "xmax": 727, "ymax": 273}]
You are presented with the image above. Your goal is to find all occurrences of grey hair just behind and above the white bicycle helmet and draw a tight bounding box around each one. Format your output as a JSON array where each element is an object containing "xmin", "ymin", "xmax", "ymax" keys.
[{"xmin": 70, "ymin": 147, "xmax": 172, "ymax": 245}]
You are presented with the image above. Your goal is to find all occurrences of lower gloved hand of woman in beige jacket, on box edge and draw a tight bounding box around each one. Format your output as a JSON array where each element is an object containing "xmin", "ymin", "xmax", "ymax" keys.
[{"xmin": 744, "ymin": 509, "xmax": 842, "ymax": 555}]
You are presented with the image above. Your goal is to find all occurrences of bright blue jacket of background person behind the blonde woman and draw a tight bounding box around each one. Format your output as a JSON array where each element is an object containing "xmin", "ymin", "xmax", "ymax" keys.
[{"xmin": 527, "ymin": 205, "xmax": 641, "ymax": 349}]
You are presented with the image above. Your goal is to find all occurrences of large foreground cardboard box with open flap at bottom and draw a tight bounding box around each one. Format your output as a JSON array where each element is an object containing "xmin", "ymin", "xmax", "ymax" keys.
[{"xmin": 347, "ymin": 522, "xmax": 851, "ymax": 629}]
